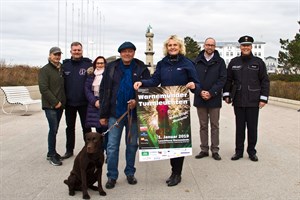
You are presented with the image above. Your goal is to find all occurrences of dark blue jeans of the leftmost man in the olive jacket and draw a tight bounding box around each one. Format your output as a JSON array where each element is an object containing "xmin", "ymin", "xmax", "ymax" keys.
[{"xmin": 45, "ymin": 109, "xmax": 63, "ymax": 156}]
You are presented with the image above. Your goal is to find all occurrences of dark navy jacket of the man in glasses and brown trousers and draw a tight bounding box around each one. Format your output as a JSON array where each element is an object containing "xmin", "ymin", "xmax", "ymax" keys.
[{"xmin": 194, "ymin": 50, "xmax": 227, "ymax": 108}]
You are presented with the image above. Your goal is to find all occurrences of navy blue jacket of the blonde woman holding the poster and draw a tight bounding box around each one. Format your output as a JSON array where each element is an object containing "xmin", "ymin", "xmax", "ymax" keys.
[{"xmin": 142, "ymin": 55, "xmax": 200, "ymax": 93}]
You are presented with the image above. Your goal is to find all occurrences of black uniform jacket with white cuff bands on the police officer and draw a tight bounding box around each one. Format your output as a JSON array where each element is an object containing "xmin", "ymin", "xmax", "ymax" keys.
[{"xmin": 223, "ymin": 54, "xmax": 270, "ymax": 107}]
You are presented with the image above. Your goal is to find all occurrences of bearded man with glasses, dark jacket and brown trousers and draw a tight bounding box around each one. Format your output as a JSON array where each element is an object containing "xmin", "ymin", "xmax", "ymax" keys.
[{"xmin": 194, "ymin": 38, "xmax": 227, "ymax": 160}]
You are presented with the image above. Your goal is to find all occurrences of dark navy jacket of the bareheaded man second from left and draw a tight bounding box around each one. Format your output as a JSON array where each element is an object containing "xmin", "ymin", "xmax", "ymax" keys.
[{"xmin": 63, "ymin": 58, "xmax": 92, "ymax": 106}]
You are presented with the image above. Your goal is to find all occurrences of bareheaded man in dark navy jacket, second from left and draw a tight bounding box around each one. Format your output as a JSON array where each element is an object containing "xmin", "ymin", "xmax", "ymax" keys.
[{"xmin": 62, "ymin": 42, "xmax": 93, "ymax": 159}]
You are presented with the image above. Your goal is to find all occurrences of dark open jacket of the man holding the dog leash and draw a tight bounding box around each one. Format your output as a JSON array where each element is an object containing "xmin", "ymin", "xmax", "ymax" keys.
[{"xmin": 100, "ymin": 59, "xmax": 150, "ymax": 119}]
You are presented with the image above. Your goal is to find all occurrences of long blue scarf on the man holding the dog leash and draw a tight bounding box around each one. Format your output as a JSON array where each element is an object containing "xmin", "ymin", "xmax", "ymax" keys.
[{"xmin": 116, "ymin": 61, "xmax": 135, "ymax": 117}]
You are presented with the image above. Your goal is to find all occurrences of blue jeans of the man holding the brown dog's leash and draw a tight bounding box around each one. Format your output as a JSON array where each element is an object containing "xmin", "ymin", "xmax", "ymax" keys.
[{"xmin": 107, "ymin": 117, "xmax": 138, "ymax": 180}]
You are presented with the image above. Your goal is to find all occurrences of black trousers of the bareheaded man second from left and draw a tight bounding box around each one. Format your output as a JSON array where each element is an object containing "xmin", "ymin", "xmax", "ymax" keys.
[{"xmin": 65, "ymin": 105, "xmax": 91, "ymax": 152}]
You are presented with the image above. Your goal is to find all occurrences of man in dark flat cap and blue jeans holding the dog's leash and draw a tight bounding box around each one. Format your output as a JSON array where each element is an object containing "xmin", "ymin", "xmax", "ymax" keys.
[{"xmin": 100, "ymin": 42, "xmax": 150, "ymax": 189}]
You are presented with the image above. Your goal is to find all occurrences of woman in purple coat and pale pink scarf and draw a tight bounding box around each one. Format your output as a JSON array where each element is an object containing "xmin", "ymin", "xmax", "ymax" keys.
[{"xmin": 85, "ymin": 56, "xmax": 107, "ymax": 138}]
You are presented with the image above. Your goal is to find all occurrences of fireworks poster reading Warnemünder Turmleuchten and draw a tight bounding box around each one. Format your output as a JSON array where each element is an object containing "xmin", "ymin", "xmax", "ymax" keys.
[{"xmin": 137, "ymin": 86, "xmax": 192, "ymax": 161}]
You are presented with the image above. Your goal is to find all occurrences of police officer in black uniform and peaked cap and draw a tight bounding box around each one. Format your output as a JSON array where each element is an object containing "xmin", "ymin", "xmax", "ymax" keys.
[{"xmin": 223, "ymin": 36, "xmax": 270, "ymax": 161}]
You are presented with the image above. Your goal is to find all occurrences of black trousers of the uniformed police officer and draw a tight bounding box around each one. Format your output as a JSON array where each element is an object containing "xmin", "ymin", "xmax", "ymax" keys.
[{"xmin": 234, "ymin": 106, "xmax": 259, "ymax": 155}]
